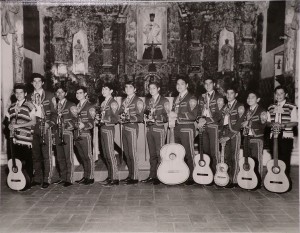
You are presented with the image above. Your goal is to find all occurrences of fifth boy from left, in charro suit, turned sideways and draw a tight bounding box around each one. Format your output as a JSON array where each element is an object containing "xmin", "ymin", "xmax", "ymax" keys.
[{"xmin": 96, "ymin": 83, "xmax": 119, "ymax": 187}]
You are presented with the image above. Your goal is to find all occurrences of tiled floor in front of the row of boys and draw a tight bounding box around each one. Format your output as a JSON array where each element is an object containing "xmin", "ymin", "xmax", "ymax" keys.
[{"xmin": 0, "ymin": 167, "xmax": 299, "ymax": 233}]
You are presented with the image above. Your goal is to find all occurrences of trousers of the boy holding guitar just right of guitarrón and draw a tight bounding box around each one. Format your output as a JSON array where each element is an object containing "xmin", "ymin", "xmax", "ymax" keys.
[{"xmin": 203, "ymin": 124, "xmax": 219, "ymax": 173}]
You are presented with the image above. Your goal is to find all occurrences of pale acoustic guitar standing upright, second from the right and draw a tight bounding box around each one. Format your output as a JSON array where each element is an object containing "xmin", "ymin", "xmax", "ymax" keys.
[{"xmin": 237, "ymin": 127, "xmax": 258, "ymax": 190}]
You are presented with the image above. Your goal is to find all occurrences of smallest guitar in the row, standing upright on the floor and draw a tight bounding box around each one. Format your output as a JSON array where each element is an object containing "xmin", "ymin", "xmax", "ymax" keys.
[{"xmin": 214, "ymin": 139, "xmax": 229, "ymax": 187}]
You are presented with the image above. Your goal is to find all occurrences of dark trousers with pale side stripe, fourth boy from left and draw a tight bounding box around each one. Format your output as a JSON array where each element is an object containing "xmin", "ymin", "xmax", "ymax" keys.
[{"xmin": 75, "ymin": 132, "xmax": 95, "ymax": 179}]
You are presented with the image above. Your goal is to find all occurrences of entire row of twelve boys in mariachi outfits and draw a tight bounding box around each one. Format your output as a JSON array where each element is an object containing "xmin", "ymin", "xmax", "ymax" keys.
[{"xmin": 8, "ymin": 73, "xmax": 297, "ymax": 189}]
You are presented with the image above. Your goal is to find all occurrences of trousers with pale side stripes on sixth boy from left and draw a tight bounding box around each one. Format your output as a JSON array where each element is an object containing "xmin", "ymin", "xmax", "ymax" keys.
[{"xmin": 122, "ymin": 123, "xmax": 139, "ymax": 180}]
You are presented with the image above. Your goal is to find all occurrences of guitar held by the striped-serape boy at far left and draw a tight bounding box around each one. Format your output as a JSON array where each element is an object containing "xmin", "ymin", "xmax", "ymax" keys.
[{"xmin": 7, "ymin": 122, "xmax": 28, "ymax": 191}]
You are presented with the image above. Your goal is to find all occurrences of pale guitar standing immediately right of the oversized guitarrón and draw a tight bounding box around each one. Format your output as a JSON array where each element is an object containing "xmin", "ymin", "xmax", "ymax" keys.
[{"xmin": 193, "ymin": 124, "xmax": 214, "ymax": 184}]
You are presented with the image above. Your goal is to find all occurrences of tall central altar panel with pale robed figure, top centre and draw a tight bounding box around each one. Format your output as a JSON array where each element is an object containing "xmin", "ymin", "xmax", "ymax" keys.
[{"xmin": 137, "ymin": 6, "xmax": 167, "ymax": 60}]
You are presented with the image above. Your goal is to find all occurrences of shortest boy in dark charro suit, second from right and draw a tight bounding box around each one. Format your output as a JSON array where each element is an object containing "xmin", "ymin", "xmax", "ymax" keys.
[{"xmin": 242, "ymin": 91, "xmax": 267, "ymax": 181}]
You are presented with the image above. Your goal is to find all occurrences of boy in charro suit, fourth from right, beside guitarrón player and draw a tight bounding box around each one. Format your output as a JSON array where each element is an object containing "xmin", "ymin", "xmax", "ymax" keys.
[{"xmin": 198, "ymin": 77, "xmax": 224, "ymax": 173}]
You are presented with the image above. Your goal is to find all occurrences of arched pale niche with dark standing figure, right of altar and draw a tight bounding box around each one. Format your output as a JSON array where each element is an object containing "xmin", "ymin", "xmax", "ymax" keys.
[{"xmin": 218, "ymin": 28, "xmax": 234, "ymax": 73}]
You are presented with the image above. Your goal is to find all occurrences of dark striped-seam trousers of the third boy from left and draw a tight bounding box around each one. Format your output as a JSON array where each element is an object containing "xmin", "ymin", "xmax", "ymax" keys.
[{"xmin": 55, "ymin": 131, "xmax": 74, "ymax": 183}]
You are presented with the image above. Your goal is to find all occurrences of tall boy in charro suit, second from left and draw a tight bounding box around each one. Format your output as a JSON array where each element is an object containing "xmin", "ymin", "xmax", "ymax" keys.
[{"xmin": 27, "ymin": 73, "xmax": 56, "ymax": 189}]
